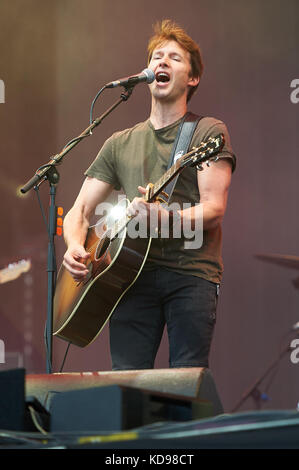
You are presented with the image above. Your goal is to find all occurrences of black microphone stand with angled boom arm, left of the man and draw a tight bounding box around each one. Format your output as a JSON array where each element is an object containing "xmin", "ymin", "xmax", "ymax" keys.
[{"xmin": 20, "ymin": 86, "xmax": 133, "ymax": 374}]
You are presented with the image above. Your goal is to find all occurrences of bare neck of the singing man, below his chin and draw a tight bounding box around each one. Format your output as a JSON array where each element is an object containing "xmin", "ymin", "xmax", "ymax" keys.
[{"xmin": 150, "ymin": 97, "xmax": 187, "ymax": 129}]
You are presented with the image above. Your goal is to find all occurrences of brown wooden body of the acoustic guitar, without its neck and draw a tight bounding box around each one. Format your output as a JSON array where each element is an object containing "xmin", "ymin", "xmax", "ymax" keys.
[{"xmin": 53, "ymin": 200, "xmax": 151, "ymax": 347}]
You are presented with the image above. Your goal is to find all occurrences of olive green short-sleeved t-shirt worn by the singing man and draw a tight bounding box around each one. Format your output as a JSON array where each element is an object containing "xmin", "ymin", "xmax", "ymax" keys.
[{"xmin": 85, "ymin": 117, "xmax": 235, "ymax": 283}]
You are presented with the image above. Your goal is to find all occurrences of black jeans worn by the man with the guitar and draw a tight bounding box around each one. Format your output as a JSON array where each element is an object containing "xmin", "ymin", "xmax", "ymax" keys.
[{"xmin": 110, "ymin": 268, "xmax": 219, "ymax": 370}]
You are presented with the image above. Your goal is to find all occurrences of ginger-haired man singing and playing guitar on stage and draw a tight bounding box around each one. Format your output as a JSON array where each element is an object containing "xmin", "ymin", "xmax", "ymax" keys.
[{"xmin": 64, "ymin": 20, "xmax": 235, "ymax": 370}]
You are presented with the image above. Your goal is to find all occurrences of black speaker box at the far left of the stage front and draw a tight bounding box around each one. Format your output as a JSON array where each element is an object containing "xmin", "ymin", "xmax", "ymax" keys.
[{"xmin": 0, "ymin": 368, "xmax": 50, "ymax": 432}]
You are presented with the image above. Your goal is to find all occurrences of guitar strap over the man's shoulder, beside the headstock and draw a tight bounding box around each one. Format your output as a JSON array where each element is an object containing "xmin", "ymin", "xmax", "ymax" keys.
[{"xmin": 163, "ymin": 112, "xmax": 203, "ymax": 202}]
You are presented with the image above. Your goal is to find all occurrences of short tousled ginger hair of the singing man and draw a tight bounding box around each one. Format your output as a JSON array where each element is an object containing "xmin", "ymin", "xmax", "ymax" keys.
[{"xmin": 147, "ymin": 20, "xmax": 203, "ymax": 101}]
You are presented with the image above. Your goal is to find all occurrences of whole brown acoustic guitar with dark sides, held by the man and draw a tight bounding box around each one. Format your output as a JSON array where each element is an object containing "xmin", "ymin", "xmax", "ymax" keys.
[{"xmin": 53, "ymin": 134, "xmax": 224, "ymax": 347}]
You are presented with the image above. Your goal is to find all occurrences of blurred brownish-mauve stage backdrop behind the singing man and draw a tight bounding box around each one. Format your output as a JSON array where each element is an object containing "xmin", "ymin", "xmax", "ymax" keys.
[{"xmin": 0, "ymin": 0, "xmax": 299, "ymax": 411}]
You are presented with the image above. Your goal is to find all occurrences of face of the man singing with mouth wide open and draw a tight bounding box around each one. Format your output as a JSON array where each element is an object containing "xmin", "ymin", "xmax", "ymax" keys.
[{"xmin": 149, "ymin": 41, "xmax": 199, "ymax": 102}]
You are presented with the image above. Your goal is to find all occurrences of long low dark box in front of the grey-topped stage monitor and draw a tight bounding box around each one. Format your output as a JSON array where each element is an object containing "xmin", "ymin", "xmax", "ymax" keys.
[{"xmin": 50, "ymin": 385, "xmax": 214, "ymax": 432}]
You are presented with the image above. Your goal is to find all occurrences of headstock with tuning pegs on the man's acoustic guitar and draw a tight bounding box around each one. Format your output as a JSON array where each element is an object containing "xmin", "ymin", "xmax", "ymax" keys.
[{"xmin": 180, "ymin": 134, "xmax": 225, "ymax": 170}]
